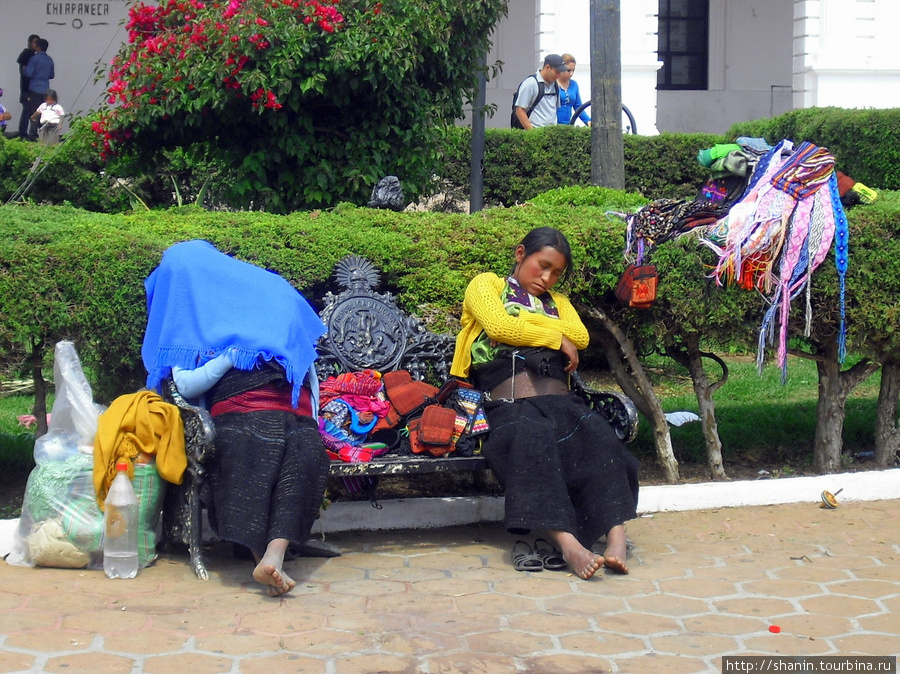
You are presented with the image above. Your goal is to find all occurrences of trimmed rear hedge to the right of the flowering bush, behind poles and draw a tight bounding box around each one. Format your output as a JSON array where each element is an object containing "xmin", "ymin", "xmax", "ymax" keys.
[{"xmin": 443, "ymin": 108, "xmax": 900, "ymax": 206}]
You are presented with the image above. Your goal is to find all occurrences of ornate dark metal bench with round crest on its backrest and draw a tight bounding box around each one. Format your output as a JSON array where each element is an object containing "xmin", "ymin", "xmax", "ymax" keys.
[{"xmin": 163, "ymin": 255, "xmax": 637, "ymax": 580}]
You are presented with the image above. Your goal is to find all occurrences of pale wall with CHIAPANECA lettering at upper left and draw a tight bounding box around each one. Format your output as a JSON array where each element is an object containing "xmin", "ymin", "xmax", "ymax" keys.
[{"xmin": 0, "ymin": 0, "xmax": 129, "ymax": 131}]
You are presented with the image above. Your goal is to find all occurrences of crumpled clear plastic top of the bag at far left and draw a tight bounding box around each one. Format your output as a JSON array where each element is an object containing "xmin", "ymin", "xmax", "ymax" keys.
[{"xmin": 34, "ymin": 342, "xmax": 100, "ymax": 464}]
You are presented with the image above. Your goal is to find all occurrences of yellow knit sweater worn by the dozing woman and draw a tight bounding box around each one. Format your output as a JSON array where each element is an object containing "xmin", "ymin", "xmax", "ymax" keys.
[{"xmin": 450, "ymin": 272, "xmax": 588, "ymax": 377}]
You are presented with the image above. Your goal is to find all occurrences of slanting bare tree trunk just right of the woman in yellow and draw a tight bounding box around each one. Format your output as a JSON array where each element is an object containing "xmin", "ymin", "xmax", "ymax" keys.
[{"xmin": 579, "ymin": 306, "xmax": 680, "ymax": 484}]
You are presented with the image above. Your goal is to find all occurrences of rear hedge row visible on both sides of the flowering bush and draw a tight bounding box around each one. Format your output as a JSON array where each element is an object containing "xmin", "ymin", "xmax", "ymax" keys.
[{"xmin": 0, "ymin": 108, "xmax": 900, "ymax": 212}]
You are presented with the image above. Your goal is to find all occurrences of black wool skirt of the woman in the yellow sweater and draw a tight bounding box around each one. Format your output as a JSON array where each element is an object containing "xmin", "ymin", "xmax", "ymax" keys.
[{"xmin": 482, "ymin": 393, "xmax": 640, "ymax": 547}]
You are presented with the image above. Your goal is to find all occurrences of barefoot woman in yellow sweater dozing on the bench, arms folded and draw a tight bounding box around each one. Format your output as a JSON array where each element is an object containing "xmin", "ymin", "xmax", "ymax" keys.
[{"xmin": 451, "ymin": 227, "xmax": 638, "ymax": 579}]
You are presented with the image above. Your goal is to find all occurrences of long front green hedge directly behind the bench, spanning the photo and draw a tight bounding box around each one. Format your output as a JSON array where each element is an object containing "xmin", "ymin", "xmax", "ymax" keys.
[{"xmin": 0, "ymin": 188, "xmax": 900, "ymax": 400}]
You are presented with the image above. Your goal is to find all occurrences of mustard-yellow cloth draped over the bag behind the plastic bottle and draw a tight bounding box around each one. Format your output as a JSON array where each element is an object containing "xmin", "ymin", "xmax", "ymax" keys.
[{"xmin": 94, "ymin": 390, "xmax": 187, "ymax": 510}]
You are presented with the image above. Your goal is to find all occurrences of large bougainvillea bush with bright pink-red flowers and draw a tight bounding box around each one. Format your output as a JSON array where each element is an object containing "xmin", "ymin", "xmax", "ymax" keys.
[{"xmin": 93, "ymin": 0, "xmax": 507, "ymax": 212}]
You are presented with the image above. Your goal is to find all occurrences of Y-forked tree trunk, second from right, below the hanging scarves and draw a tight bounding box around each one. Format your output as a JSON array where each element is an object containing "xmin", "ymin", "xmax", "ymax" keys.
[{"xmin": 804, "ymin": 341, "xmax": 878, "ymax": 474}]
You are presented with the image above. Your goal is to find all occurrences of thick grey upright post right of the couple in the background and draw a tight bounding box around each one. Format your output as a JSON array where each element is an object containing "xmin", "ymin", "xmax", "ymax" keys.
[{"xmin": 591, "ymin": 0, "xmax": 625, "ymax": 190}]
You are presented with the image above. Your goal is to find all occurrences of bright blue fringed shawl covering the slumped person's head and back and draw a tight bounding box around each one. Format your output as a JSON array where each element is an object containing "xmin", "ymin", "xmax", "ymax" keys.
[{"xmin": 141, "ymin": 241, "xmax": 325, "ymax": 406}]
